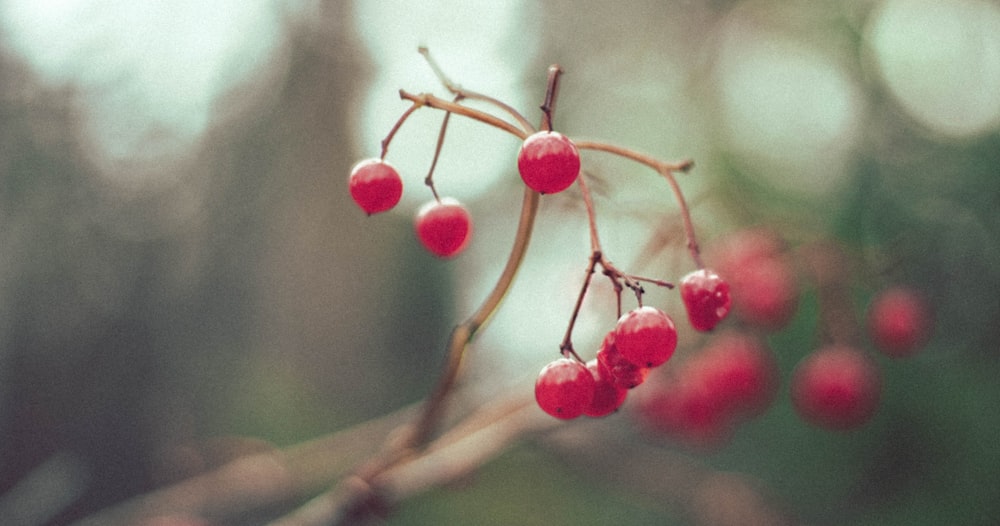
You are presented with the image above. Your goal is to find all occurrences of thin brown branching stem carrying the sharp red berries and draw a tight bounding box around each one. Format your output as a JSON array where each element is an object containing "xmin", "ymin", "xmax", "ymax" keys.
[{"xmin": 326, "ymin": 55, "xmax": 702, "ymax": 524}]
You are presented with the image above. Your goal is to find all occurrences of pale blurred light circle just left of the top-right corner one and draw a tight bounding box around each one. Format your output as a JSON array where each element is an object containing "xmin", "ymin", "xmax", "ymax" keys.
[{"xmin": 715, "ymin": 20, "xmax": 863, "ymax": 198}]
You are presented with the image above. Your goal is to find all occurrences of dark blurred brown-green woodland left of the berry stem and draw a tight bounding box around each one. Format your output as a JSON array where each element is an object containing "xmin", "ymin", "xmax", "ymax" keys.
[{"xmin": 0, "ymin": 6, "xmax": 450, "ymax": 523}]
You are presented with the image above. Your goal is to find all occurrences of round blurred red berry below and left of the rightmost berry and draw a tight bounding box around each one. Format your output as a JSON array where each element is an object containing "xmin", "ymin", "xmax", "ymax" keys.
[{"xmin": 791, "ymin": 345, "xmax": 882, "ymax": 430}]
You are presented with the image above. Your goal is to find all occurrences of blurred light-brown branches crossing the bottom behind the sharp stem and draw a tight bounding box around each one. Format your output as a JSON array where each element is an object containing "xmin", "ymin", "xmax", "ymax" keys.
[{"xmin": 68, "ymin": 385, "xmax": 794, "ymax": 526}]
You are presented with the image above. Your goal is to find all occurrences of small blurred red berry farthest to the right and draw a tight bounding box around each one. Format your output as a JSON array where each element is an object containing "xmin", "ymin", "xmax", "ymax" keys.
[{"xmin": 868, "ymin": 287, "xmax": 933, "ymax": 358}]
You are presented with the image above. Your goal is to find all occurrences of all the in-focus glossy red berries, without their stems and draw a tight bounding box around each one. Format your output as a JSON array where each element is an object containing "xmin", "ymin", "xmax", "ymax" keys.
[{"xmin": 349, "ymin": 125, "xmax": 730, "ymax": 419}]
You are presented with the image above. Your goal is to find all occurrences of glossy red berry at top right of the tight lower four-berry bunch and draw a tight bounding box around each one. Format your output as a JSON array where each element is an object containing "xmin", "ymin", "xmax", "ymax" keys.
[{"xmin": 615, "ymin": 306, "xmax": 677, "ymax": 367}]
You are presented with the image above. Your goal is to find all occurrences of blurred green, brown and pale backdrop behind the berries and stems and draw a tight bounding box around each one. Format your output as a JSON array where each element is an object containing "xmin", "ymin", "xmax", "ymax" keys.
[{"xmin": 0, "ymin": 0, "xmax": 1000, "ymax": 526}]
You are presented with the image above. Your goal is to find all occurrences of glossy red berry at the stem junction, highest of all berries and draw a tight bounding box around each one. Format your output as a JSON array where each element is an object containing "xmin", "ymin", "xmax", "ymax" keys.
[{"xmin": 517, "ymin": 131, "xmax": 580, "ymax": 194}]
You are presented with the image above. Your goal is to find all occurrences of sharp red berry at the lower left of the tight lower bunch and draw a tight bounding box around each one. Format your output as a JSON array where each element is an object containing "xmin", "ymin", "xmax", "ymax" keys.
[{"xmin": 535, "ymin": 358, "xmax": 597, "ymax": 420}]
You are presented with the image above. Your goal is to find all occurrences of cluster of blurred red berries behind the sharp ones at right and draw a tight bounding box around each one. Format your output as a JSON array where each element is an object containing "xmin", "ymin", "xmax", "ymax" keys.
[{"xmin": 635, "ymin": 230, "xmax": 932, "ymax": 447}]
